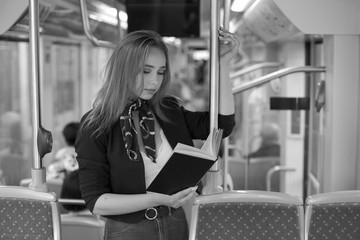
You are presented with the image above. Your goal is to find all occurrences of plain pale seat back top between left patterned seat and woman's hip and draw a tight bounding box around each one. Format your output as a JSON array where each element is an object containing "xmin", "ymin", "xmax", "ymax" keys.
[{"xmin": 61, "ymin": 214, "xmax": 105, "ymax": 240}]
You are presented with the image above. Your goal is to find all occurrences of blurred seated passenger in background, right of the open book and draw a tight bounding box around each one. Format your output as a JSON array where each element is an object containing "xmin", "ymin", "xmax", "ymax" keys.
[{"xmin": 248, "ymin": 123, "xmax": 280, "ymax": 158}]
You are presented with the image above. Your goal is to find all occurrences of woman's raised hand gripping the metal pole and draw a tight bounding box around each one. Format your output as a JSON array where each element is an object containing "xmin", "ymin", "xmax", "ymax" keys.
[{"xmin": 219, "ymin": 27, "xmax": 240, "ymax": 64}]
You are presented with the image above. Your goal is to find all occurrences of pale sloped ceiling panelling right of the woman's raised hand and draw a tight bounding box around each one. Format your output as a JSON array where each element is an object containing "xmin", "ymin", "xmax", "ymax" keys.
[{"xmin": 232, "ymin": 0, "xmax": 360, "ymax": 42}]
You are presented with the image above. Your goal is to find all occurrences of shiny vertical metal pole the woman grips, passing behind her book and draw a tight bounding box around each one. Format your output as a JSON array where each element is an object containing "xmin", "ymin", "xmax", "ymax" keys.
[{"xmin": 203, "ymin": 0, "xmax": 222, "ymax": 194}]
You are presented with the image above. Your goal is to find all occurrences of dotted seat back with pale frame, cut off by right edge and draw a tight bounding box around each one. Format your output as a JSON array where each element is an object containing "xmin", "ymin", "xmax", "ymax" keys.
[{"xmin": 305, "ymin": 190, "xmax": 360, "ymax": 240}]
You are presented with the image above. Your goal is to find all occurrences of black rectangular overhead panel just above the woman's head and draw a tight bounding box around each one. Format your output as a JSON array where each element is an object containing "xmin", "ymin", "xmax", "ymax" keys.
[{"xmin": 126, "ymin": 0, "xmax": 200, "ymax": 37}]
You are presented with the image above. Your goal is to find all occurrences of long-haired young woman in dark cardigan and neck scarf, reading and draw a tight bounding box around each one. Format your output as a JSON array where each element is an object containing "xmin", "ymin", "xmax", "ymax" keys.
[{"xmin": 75, "ymin": 29, "xmax": 240, "ymax": 240}]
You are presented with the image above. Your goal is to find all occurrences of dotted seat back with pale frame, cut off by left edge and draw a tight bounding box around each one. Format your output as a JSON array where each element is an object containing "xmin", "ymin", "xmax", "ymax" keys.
[{"xmin": 0, "ymin": 186, "xmax": 61, "ymax": 240}]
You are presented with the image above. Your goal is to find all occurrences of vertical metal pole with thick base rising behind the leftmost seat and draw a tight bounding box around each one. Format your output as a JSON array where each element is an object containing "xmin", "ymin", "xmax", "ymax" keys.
[{"xmin": 29, "ymin": 0, "xmax": 47, "ymax": 191}]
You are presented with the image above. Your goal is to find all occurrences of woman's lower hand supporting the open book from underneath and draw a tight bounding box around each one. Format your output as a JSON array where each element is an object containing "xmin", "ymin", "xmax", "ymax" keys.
[{"xmin": 148, "ymin": 187, "xmax": 197, "ymax": 208}]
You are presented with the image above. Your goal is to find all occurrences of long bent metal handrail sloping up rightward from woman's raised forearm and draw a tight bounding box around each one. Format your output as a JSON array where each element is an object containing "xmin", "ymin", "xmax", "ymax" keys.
[{"xmin": 233, "ymin": 66, "xmax": 326, "ymax": 94}]
